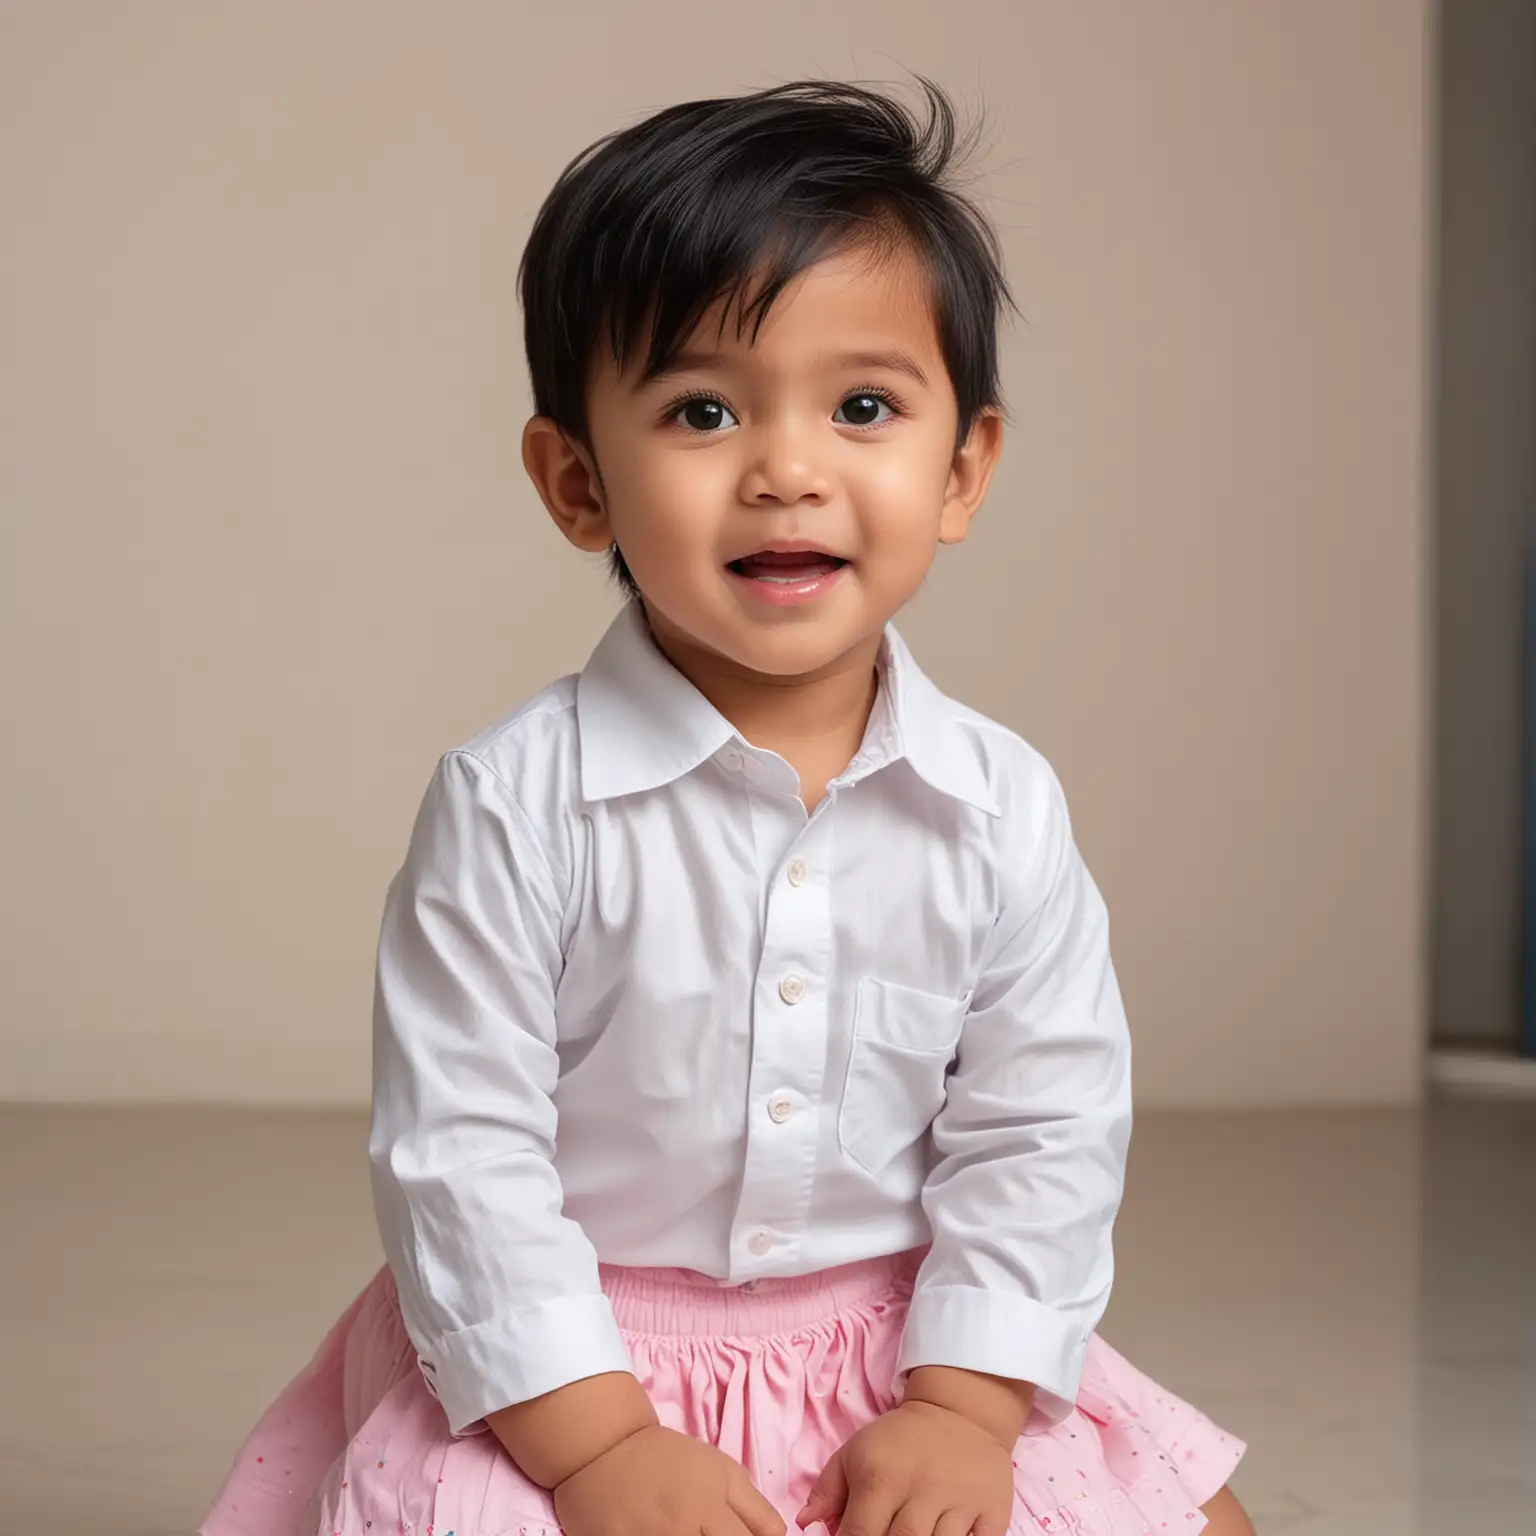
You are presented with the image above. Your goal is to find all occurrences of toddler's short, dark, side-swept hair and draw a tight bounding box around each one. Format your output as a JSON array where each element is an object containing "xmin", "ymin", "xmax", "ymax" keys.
[{"xmin": 518, "ymin": 80, "xmax": 1012, "ymax": 596}]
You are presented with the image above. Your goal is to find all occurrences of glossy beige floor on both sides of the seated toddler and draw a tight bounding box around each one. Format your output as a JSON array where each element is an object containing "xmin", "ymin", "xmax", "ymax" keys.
[{"xmin": 0, "ymin": 1100, "xmax": 1536, "ymax": 1536}]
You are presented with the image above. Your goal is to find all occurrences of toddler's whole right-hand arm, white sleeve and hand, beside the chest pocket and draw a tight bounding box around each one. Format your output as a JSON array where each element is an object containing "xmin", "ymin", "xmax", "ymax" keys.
[{"xmin": 799, "ymin": 776, "xmax": 1130, "ymax": 1536}]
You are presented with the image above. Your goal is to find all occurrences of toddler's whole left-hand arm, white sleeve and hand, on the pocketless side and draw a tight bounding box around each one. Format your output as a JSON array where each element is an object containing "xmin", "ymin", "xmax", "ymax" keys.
[{"xmin": 370, "ymin": 753, "xmax": 783, "ymax": 1536}]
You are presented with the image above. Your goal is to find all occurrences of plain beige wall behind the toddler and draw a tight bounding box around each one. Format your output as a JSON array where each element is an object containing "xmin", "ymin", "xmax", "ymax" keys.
[{"xmin": 0, "ymin": 0, "xmax": 1428, "ymax": 1104}]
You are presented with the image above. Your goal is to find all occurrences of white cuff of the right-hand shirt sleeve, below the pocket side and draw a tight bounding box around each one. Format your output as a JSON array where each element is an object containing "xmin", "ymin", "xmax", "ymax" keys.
[{"xmin": 897, "ymin": 1286, "xmax": 1087, "ymax": 1424}]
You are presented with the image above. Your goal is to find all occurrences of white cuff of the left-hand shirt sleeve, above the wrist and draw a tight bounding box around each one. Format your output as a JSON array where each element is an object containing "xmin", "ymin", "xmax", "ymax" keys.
[{"xmin": 418, "ymin": 1293, "xmax": 634, "ymax": 1435}]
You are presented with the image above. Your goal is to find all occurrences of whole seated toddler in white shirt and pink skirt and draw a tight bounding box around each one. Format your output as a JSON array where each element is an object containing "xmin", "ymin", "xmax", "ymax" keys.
[{"xmin": 203, "ymin": 83, "xmax": 1252, "ymax": 1536}]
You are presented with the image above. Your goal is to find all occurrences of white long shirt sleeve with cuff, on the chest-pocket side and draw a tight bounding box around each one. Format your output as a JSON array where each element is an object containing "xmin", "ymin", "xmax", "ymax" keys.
[{"xmin": 899, "ymin": 776, "xmax": 1130, "ymax": 1422}]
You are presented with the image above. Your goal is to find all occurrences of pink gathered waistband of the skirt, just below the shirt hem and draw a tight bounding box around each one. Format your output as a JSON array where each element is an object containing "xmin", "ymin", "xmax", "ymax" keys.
[{"xmin": 599, "ymin": 1249, "xmax": 923, "ymax": 1338}]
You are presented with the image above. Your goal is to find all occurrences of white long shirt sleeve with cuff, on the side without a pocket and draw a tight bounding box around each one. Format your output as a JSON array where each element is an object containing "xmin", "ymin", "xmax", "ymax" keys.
[{"xmin": 369, "ymin": 751, "xmax": 631, "ymax": 1435}]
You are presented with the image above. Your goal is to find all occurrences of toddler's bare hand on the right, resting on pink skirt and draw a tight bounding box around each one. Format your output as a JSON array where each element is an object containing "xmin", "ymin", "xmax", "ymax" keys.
[{"xmin": 796, "ymin": 1399, "xmax": 1014, "ymax": 1536}]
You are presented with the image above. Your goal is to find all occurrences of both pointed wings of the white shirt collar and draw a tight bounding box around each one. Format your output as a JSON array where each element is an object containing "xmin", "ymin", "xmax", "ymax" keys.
[{"xmin": 576, "ymin": 599, "xmax": 1000, "ymax": 816}]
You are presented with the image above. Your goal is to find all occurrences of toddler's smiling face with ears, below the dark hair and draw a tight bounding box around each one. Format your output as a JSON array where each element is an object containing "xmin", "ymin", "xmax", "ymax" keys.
[{"xmin": 525, "ymin": 241, "xmax": 1001, "ymax": 679}]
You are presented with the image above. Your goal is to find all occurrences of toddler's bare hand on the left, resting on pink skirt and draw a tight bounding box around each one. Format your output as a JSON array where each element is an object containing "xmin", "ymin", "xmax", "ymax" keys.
[{"xmin": 554, "ymin": 1424, "xmax": 785, "ymax": 1536}]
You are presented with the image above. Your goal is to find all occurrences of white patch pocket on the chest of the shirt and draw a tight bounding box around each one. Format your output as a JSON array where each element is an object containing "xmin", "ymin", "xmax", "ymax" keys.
[{"xmin": 837, "ymin": 977, "xmax": 969, "ymax": 1174}]
